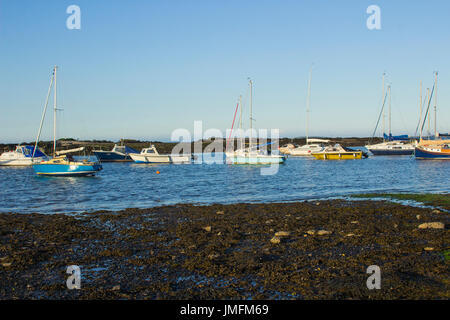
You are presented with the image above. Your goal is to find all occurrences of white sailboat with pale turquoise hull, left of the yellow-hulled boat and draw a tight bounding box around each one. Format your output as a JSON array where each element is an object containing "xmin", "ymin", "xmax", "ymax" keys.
[{"xmin": 225, "ymin": 80, "xmax": 286, "ymax": 164}]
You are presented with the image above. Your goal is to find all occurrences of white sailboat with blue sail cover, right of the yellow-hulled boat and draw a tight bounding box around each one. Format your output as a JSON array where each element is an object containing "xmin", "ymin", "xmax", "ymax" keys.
[{"xmin": 365, "ymin": 73, "xmax": 415, "ymax": 156}]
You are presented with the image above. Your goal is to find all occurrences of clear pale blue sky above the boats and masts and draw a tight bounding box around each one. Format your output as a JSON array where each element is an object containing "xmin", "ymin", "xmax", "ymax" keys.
[{"xmin": 0, "ymin": 0, "xmax": 450, "ymax": 142}]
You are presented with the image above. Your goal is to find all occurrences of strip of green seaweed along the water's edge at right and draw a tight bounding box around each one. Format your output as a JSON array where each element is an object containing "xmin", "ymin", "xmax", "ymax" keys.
[{"xmin": 351, "ymin": 193, "xmax": 450, "ymax": 210}]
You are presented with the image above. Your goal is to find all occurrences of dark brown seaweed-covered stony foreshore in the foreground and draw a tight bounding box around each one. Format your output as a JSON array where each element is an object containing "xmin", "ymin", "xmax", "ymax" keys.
[{"xmin": 0, "ymin": 200, "xmax": 450, "ymax": 299}]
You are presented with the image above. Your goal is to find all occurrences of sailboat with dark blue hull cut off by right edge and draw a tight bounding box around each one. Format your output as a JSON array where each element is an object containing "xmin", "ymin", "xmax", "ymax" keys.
[{"xmin": 414, "ymin": 72, "xmax": 450, "ymax": 160}]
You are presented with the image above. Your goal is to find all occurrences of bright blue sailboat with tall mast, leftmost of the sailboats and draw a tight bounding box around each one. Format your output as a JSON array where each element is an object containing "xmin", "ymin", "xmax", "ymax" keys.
[{"xmin": 32, "ymin": 66, "xmax": 103, "ymax": 176}]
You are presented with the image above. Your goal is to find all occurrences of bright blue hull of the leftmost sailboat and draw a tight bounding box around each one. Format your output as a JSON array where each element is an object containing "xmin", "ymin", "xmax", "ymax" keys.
[{"xmin": 33, "ymin": 163, "xmax": 103, "ymax": 176}]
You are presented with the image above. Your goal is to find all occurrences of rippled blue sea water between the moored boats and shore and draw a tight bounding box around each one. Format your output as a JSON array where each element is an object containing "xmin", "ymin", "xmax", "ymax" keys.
[{"xmin": 0, "ymin": 156, "xmax": 450, "ymax": 213}]
